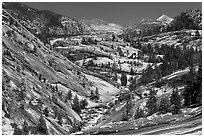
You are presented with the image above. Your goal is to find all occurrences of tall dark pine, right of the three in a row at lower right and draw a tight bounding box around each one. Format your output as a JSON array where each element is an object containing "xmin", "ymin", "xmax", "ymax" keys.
[{"xmin": 170, "ymin": 90, "xmax": 181, "ymax": 114}]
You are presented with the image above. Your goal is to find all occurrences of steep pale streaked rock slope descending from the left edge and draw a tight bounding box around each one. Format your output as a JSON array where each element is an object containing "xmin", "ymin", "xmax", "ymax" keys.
[{"xmin": 2, "ymin": 6, "xmax": 119, "ymax": 134}]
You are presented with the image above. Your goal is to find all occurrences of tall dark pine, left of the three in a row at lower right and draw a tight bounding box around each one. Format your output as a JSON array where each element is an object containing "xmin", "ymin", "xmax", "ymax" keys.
[{"xmin": 146, "ymin": 90, "xmax": 158, "ymax": 116}]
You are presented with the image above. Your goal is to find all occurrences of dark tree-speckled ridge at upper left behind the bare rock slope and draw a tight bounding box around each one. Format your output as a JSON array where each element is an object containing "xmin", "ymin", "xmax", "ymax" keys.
[{"xmin": 2, "ymin": 2, "xmax": 83, "ymax": 39}]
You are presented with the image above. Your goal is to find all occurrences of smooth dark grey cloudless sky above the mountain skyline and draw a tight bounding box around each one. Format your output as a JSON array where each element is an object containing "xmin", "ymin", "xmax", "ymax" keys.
[{"xmin": 24, "ymin": 2, "xmax": 202, "ymax": 25}]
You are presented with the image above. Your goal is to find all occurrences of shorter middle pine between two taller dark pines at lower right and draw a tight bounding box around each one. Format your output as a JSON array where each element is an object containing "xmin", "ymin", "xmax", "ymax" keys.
[{"xmin": 159, "ymin": 97, "xmax": 170, "ymax": 114}]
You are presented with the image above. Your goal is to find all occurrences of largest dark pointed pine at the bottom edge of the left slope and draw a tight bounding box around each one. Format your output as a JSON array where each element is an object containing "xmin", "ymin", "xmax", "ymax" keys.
[{"xmin": 36, "ymin": 115, "xmax": 48, "ymax": 135}]
